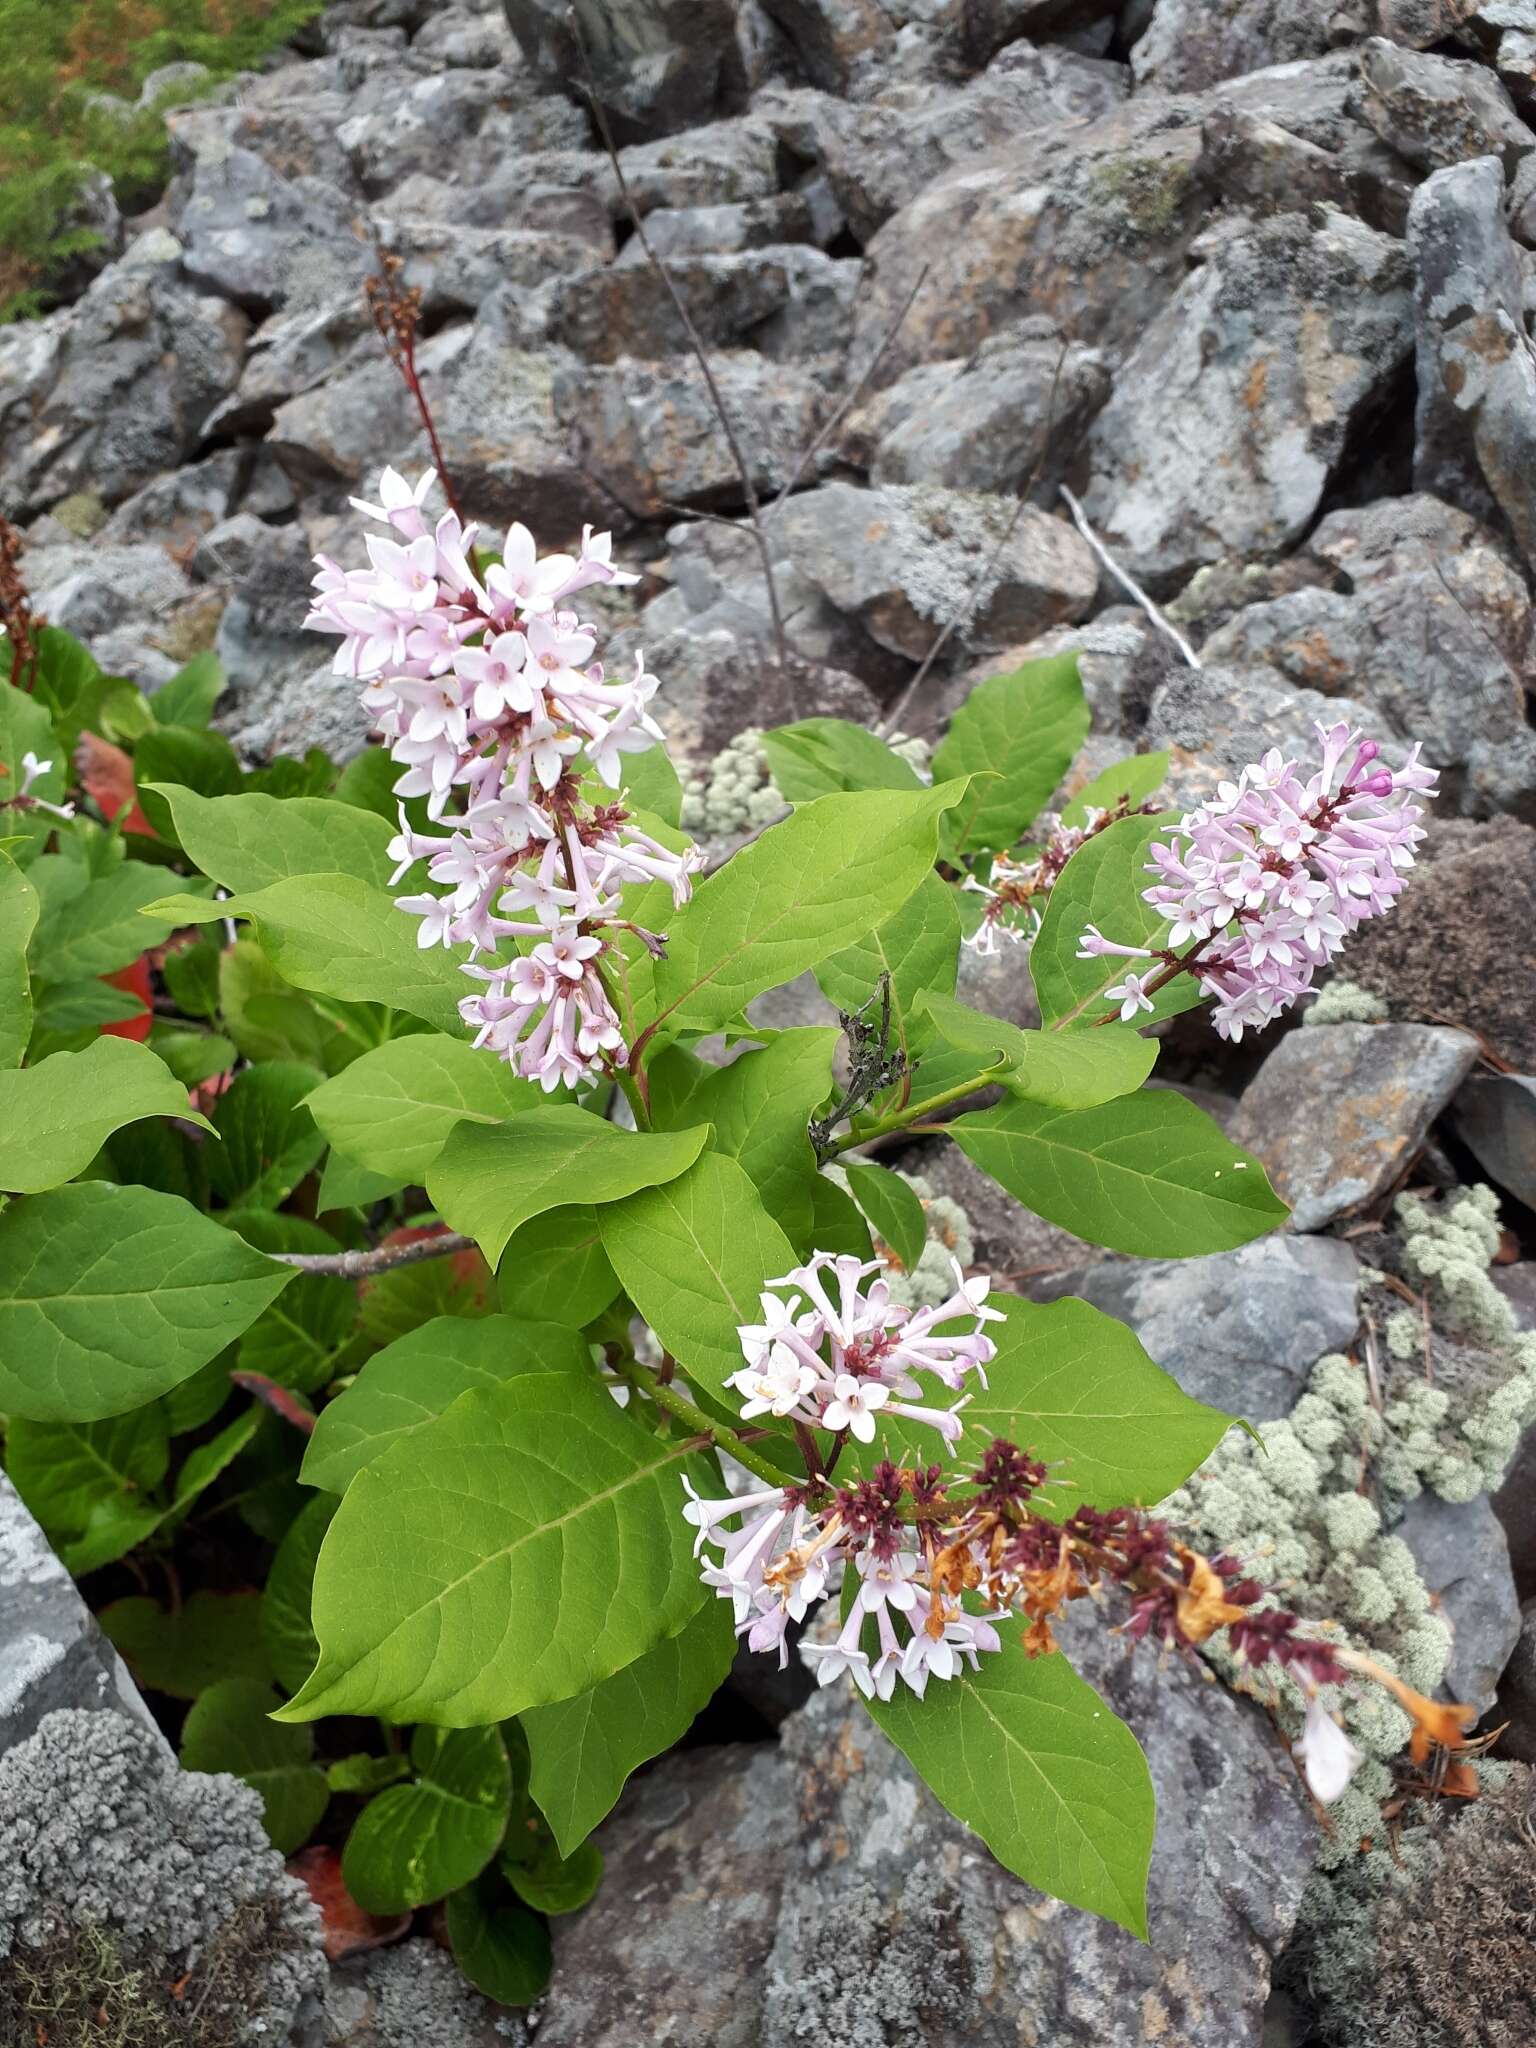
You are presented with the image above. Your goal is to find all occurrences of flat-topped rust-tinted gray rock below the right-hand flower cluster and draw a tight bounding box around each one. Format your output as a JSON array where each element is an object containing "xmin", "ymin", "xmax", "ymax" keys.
[{"xmin": 1233, "ymin": 1024, "xmax": 1477, "ymax": 1231}]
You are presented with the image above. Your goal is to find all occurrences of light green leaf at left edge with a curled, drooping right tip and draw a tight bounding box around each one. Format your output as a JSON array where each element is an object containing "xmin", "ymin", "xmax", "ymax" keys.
[{"xmin": 0, "ymin": 1038, "xmax": 213, "ymax": 1194}]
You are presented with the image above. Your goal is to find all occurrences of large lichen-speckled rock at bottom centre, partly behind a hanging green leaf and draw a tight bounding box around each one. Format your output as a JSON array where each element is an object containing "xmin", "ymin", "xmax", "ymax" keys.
[{"xmin": 539, "ymin": 1612, "xmax": 1317, "ymax": 2048}]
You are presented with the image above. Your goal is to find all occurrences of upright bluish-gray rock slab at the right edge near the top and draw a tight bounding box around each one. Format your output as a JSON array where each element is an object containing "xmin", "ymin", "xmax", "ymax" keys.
[{"xmin": 1409, "ymin": 156, "xmax": 1536, "ymax": 563}]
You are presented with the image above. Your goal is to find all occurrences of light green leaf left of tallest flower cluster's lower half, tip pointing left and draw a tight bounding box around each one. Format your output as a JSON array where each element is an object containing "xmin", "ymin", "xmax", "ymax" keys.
[{"xmin": 151, "ymin": 874, "xmax": 479, "ymax": 1038}]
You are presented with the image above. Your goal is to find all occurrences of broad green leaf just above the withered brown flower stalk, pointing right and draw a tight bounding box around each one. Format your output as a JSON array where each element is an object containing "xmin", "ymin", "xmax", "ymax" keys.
[{"xmin": 856, "ymin": 1292, "xmax": 1231, "ymax": 1518}]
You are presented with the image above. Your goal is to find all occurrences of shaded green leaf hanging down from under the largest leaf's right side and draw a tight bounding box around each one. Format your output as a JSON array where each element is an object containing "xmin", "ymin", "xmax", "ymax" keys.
[{"xmin": 522, "ymin": 1599, "xmax": 735, "ymax": 1855}]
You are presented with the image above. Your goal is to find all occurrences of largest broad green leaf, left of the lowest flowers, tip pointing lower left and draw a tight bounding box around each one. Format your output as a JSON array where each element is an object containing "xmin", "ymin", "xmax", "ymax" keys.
[{"xmin": 285, "ymin": 1372, "xmax": 709, "ymax": 1726}]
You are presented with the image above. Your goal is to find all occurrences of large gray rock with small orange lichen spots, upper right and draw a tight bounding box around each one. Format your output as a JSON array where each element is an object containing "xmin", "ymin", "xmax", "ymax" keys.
[{"xmin": 1085, "ymin": 213, "xmax": 1411, "ymax": 586}]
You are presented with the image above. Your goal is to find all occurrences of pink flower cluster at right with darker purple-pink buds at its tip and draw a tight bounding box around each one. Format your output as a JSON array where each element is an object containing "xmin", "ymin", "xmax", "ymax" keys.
[{"xmin": 1077, "ymin": 725, "xmax": 1436, "ymax": 1038}]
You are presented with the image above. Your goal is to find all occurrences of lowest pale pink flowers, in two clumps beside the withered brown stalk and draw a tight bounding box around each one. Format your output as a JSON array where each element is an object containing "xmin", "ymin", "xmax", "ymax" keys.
[{"xmin": 684, "ymin": 1251, "xmax": 1001, "ymax": 1700}]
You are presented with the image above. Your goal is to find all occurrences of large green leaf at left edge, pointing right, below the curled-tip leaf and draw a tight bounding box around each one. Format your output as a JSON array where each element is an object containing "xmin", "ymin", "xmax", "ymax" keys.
[{"xmin": 0, "ymin": 1182, "xmax": 293, "ymax": 1421}]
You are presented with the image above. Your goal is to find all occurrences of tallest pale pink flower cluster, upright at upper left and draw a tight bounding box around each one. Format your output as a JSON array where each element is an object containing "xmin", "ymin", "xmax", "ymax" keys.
[{"xmin": 305, "ymin": 469, "xmax": 698, "ymax": 1090}]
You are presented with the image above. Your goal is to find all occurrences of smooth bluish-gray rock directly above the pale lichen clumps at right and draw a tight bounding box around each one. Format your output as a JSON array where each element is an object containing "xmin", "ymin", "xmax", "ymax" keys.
[{"xmin": 1036, "ymin": 1237, "xmax": 1360, "ymax": 1421}]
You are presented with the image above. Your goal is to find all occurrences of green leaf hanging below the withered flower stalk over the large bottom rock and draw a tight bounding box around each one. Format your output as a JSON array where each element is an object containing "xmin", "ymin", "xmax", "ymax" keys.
[{"xmin": 868, "ymin": 1624, "xmax": 1157, "ymax": 1939}]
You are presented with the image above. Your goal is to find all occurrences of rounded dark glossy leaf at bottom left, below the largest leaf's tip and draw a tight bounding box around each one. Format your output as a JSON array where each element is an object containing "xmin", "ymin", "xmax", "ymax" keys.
[{"xmin": 342, "ymin": 1729, "xmax": 512, "ymax": 1913}]
